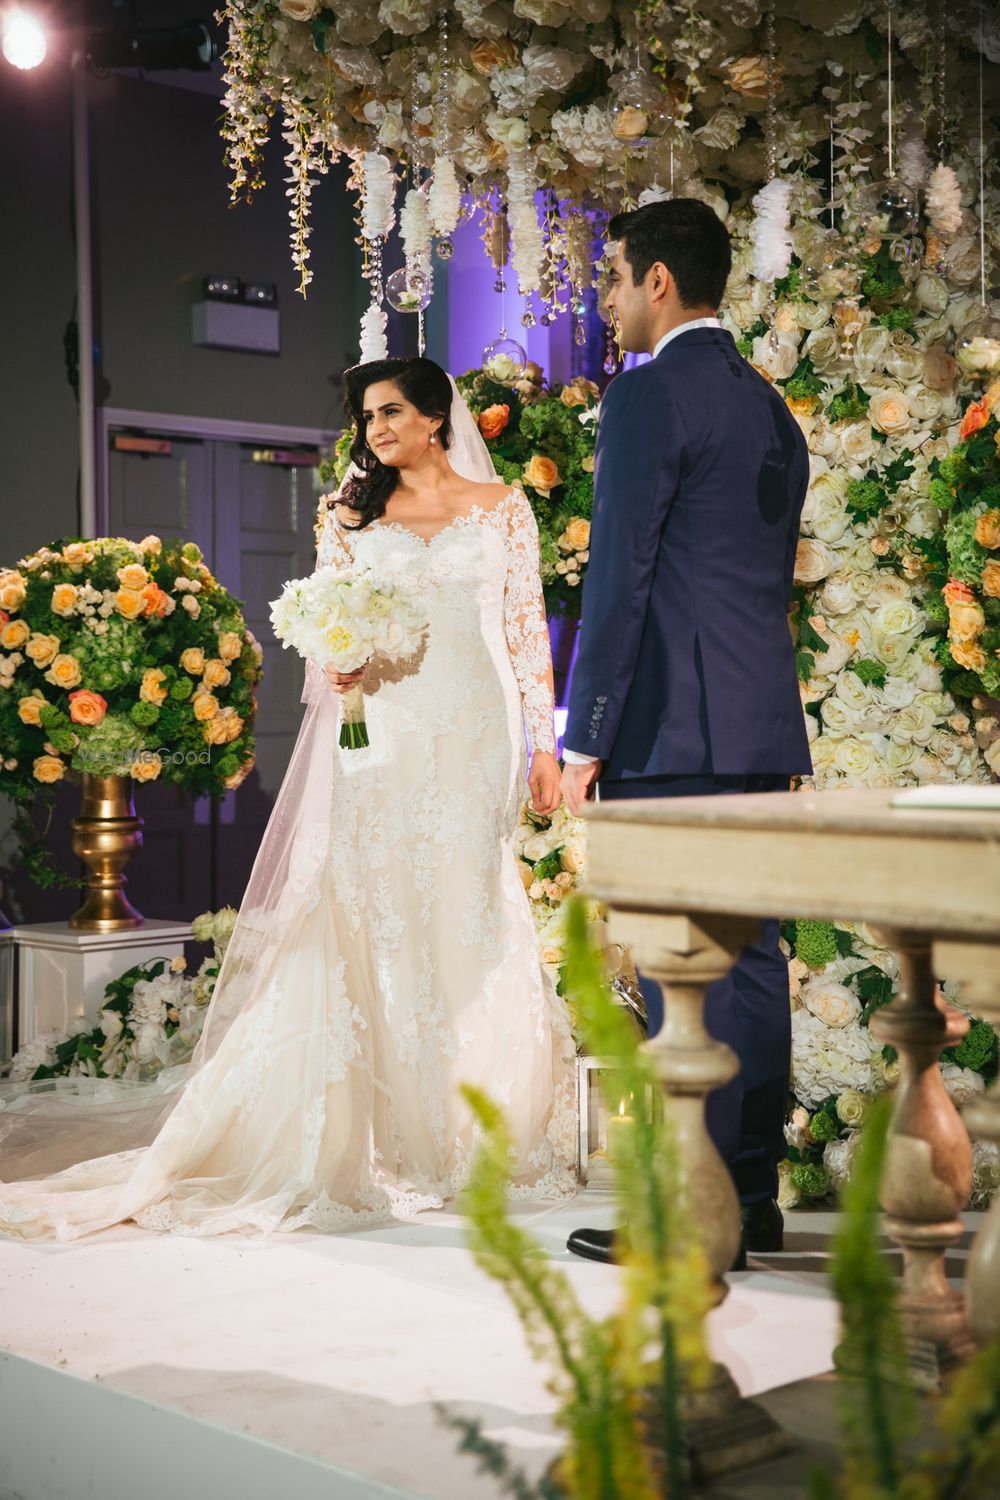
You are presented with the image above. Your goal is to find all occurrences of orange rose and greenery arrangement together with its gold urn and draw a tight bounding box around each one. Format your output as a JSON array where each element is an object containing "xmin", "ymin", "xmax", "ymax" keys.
[{"xmin": 0, "ymin": 536, "xmax": 262, "ymax": 927}]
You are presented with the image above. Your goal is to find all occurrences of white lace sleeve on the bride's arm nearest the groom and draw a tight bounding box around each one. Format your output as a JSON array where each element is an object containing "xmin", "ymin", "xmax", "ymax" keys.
[{"xmin": 504, "ymin": 489, "xmax": 556, "ymax": 755}]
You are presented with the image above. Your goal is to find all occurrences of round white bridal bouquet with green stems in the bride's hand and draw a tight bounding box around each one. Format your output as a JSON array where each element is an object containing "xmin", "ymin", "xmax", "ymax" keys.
[{"xmin": 271, "ymin": 569, "xmax": 427, "ymax": 750}]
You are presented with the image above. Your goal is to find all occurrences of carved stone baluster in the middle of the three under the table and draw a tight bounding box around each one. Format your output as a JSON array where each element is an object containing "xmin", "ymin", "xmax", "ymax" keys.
[{"xmin": 871, "ymin": 927, "xmax": 973, "ymax": 1391}]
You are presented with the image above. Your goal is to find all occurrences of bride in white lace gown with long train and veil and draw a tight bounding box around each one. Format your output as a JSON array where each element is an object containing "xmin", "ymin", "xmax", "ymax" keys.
[{"xmin": 0, "ymin": 359, "xmax": 576, "ymax": 1239}]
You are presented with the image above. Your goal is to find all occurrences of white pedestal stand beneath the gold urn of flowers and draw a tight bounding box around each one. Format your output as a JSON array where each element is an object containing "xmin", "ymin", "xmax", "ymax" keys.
[{"xmin": 13, "ymin": 918, "xmax": 190, "ymax": 1046}]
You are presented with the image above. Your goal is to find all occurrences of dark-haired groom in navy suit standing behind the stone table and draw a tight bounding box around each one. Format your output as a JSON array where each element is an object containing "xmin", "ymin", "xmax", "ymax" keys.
[{"xmin": 562, "ymin": 198, "xmax": 811, "ymax": 1260}]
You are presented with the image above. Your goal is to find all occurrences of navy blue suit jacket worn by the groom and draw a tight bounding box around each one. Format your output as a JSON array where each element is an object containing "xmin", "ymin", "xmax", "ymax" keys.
[{"xmin": 564, "ymin": 329, "xmax": 811, "ymax": 780}]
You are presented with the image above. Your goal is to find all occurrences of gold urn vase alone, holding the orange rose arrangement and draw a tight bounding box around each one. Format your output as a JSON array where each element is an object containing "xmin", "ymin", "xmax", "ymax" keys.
[{"xmin": 69, "ymin": 771, "xmax": 142, "ymax": 933}]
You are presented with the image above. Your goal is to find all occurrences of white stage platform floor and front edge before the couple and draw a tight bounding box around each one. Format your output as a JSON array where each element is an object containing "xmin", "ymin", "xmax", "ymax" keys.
[{"xmin": 0, "ymin": 1187, "xmax": 837, "ymax": 1500}]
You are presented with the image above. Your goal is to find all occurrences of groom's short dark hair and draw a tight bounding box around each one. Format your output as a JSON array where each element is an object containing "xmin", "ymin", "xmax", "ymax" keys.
[{"xmin": 607, "ymin": 198, "xmax": 733, "ymax": 308}]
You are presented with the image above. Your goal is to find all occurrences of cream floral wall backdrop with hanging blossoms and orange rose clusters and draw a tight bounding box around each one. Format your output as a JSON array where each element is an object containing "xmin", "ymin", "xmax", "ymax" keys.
[{"xmin": 236, "ymin": 0, "xmax": 1000, "ymax": 1203}]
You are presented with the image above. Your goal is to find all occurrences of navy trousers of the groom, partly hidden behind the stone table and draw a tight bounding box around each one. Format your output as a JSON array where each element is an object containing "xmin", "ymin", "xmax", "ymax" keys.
[{"xmin": 598, "ymin": 774, "xmax": 792, "ymax": 1206}]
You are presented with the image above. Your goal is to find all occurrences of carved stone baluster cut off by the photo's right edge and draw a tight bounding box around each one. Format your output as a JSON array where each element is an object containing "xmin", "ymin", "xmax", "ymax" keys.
[{"xmin": 934, "ymin": 939, "xmax": 1000, "ymax": 1344}]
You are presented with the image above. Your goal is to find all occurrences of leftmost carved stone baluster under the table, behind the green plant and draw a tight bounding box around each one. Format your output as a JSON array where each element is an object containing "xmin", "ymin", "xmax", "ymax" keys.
[{"xmin": 610, "ymin": 909, "xmax": 789, "ymax": 1482}]
